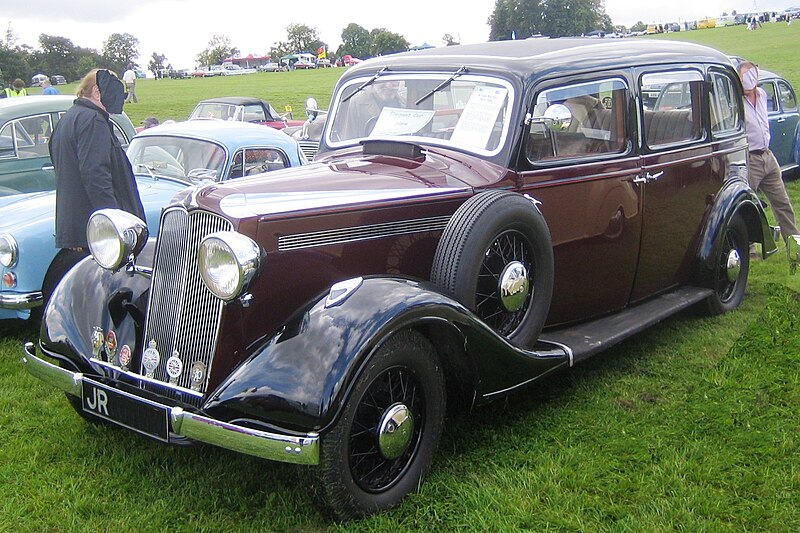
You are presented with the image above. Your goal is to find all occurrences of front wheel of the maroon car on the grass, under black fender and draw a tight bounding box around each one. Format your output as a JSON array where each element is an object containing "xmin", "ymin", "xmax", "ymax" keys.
[{"xmin": 317, "ymin": 330, "xmax": 446, "ymax": 520}]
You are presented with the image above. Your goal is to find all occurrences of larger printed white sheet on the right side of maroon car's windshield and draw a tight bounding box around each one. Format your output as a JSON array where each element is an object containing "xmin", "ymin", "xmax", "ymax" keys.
[{"xmin": 450, "ymin": 86, "xmax": 508, "ymax": 149}]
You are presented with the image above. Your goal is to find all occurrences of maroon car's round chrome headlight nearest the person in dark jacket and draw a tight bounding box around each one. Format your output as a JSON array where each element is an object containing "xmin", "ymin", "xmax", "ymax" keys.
[{"xmin": 86, "ymin": 209, "xmax": 148, "ymax": 270}]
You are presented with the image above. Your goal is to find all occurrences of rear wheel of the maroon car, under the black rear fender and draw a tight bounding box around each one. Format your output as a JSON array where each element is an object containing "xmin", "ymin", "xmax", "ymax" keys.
[{"xmin": 701, "ymin": 215, "xmax": 750, "ymax": 315}]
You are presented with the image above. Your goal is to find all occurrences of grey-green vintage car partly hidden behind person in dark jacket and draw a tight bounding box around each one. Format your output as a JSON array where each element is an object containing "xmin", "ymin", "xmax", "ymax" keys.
[{"xmin": 0, "ymin": 95, "xmax": 136, "ymax": 198}]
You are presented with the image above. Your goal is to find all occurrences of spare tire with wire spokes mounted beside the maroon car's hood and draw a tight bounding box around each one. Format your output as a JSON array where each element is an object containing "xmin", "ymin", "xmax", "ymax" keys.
[{"xmin": 431, "ymin": 191, "xmax": 553, "ymax": 348}]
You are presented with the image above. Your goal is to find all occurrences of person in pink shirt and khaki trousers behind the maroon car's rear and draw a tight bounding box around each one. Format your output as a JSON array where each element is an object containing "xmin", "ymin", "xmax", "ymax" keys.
[{"xmin": 736, "ymin": 61, "xmax": 800, "ymax": 241}]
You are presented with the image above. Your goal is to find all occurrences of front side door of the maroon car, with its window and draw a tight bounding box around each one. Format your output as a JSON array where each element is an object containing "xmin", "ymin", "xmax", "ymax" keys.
[{"xmin": 519, "ymin": 74, "xmax": 642, "ymax": 325}]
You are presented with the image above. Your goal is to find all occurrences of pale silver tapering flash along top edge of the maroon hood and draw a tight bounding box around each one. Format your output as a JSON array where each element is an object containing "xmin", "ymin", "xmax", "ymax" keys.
[{"xmin": 219, "ymin": 187, "xmax": 469, "ymax": 218}]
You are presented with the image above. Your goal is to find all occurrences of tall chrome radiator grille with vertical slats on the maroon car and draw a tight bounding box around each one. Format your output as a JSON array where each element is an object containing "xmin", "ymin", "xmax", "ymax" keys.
[{"xmin": 139, "ymin": 209, "xmax": 233, "ymax": 400}]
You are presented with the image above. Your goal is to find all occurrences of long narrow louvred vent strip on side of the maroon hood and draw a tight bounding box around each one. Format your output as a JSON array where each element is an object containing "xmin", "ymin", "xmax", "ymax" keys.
[{"xmin": 278, "ymin": 216, "xmax": 450, "ymax": 252}]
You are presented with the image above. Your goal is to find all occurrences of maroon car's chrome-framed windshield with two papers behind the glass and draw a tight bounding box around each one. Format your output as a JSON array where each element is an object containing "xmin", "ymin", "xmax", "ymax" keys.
[{"xmin": 327, "ymin": 73, "xmax": 513, "ymax": 155}]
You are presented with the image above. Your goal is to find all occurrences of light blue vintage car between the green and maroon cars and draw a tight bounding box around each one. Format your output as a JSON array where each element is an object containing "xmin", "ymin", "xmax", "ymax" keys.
[{"xmin": 0, "ymin": 121, "xmax": 306, "ymax": 319}]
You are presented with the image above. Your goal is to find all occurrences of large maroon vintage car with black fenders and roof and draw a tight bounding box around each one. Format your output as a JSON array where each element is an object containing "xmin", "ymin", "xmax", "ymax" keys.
[{"xmin": 24, "ymin": 39, "xmax": 775, "ymax": 518}]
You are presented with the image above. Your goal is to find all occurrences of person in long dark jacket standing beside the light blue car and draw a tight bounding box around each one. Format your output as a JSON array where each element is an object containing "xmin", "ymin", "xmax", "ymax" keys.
[{"xmin": 43, "ymin": 69, "xmax": 145, "ymax": 298}]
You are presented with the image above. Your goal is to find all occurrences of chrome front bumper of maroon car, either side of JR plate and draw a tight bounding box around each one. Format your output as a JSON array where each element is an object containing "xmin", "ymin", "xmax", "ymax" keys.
[{"xmin": 22, "ymin": 342, "xmax": 320, "ymax": 465}]
